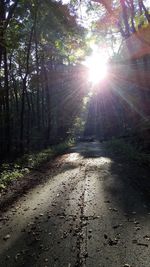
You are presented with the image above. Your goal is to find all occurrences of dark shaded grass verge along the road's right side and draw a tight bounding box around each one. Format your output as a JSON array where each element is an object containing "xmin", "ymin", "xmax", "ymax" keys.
[{"xmin": 105, "ymin": 139, "xmax": 150, "ymax": 166}]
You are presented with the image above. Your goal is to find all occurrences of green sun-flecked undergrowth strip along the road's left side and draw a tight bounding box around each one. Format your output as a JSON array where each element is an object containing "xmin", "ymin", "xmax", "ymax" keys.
[{"xmin": 0, "ymin": 139, "xmax": 73, "ymax": 191}]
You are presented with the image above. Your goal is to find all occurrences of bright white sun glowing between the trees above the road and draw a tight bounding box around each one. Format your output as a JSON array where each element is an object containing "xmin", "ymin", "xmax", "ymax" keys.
[{"xmin": 84, "ymin": 52, "xmax": 108, "ymax": 85}]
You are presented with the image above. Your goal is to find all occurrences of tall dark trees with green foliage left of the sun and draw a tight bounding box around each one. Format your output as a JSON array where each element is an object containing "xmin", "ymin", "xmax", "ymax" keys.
[{"xmin": 0, "ymin": 1, "xmax": 84, "ymax": 157}]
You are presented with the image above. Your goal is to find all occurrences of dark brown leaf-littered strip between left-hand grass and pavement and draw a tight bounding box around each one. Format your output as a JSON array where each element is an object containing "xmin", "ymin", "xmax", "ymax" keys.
[{"xmin": 0, "ymin": 159, "xmax": 77, "ymax": 212}]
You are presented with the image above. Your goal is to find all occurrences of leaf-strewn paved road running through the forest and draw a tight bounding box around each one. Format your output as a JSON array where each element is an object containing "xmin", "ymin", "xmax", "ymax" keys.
[{"xmin": 0, "ymin": 142, "xmax": 150, "ymax": 267}]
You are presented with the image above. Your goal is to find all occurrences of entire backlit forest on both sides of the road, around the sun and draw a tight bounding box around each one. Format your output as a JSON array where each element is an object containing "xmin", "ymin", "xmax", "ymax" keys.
[{"xmin": 0, "ymin": 0, "xmax": 150, "ymax": 161}]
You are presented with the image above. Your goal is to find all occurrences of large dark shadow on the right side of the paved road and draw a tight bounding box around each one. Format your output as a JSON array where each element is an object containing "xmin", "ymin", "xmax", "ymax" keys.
[{"xmin": 78, "ymin": 142, "xmax": 150, "ymax": 217}]
